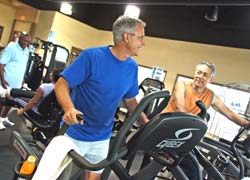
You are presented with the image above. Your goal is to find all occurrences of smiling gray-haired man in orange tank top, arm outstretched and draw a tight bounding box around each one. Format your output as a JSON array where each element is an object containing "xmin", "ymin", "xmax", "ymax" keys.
[{"xmin": 163, "ymin": 61, "xmax": 248, "ymax": 126}]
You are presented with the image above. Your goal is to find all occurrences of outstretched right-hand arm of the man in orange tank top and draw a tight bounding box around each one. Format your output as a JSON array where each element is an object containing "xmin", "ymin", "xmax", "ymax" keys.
[{"xmin": 212, "ymin": 95, "xmax": 248, "ymax": 126}]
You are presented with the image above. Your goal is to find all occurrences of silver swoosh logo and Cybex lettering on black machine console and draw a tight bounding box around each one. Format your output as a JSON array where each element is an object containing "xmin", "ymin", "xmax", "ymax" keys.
[{"xmin": 156, "ymin": 128, "xmax": 200, "ymax": 149}]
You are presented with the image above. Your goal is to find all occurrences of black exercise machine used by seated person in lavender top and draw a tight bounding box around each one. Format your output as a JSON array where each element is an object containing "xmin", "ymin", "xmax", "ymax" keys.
[{"xmin": 4, "ymin": 88, "xmax": 62, "ymax": 145}]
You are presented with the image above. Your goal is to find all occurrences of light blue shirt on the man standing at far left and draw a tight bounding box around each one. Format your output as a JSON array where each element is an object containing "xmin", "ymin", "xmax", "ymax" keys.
[{"xmin": 0, "ymin": 42, "xmax": 29, "ymax": 88}]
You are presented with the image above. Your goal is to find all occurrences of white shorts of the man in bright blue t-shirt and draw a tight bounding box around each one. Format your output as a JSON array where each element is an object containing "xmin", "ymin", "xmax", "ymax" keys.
[{"xmin": 65, "ymin": 134, "xmax": 110, "ymax": 173}]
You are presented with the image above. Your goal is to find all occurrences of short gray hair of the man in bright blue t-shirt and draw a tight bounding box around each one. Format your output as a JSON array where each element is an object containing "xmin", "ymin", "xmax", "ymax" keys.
[{"xmin": 112, "ymin": 16, "xmax": 146, "ymax": 44}]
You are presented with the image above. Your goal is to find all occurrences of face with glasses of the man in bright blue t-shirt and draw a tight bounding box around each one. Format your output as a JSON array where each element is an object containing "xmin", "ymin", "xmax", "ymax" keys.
[{"xmin": 128, "ymin": 24, "xmax": 145, "ymax": 56}]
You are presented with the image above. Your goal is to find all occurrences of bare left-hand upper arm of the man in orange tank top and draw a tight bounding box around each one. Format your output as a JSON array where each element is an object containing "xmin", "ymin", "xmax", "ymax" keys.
[{"xmin": 172, "ymin": 82, "xmax": 186, "ymax": 112}]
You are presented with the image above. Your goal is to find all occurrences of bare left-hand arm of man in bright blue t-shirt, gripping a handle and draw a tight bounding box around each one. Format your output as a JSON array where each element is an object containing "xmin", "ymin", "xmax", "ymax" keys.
[{"xmin": 54, "ymin": 77, "xmax": 82, "ymax": 124}]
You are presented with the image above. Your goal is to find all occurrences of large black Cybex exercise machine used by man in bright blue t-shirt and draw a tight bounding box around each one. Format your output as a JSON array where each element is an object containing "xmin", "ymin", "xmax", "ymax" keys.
[{"xmin": 9, "ymin": 91, "xmax": 225, "ymax": 180}]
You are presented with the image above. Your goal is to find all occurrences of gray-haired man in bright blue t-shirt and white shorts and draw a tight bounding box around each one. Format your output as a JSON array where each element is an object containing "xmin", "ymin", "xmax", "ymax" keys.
[{"xmin": 55, "ymin": 16, "xmax": 148, "ymax": 180}]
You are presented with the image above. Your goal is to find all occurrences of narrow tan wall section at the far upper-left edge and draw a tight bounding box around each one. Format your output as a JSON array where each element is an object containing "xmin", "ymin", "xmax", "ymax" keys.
[{"xmin": 0, "ymin": 3, "xmax": 16, "ymax": 46}]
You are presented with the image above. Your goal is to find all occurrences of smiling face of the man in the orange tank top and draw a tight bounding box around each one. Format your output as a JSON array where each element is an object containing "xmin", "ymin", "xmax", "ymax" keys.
[{"xmin": 194, "ymin": 65, "xmax": 212, "ymax": 88}]
